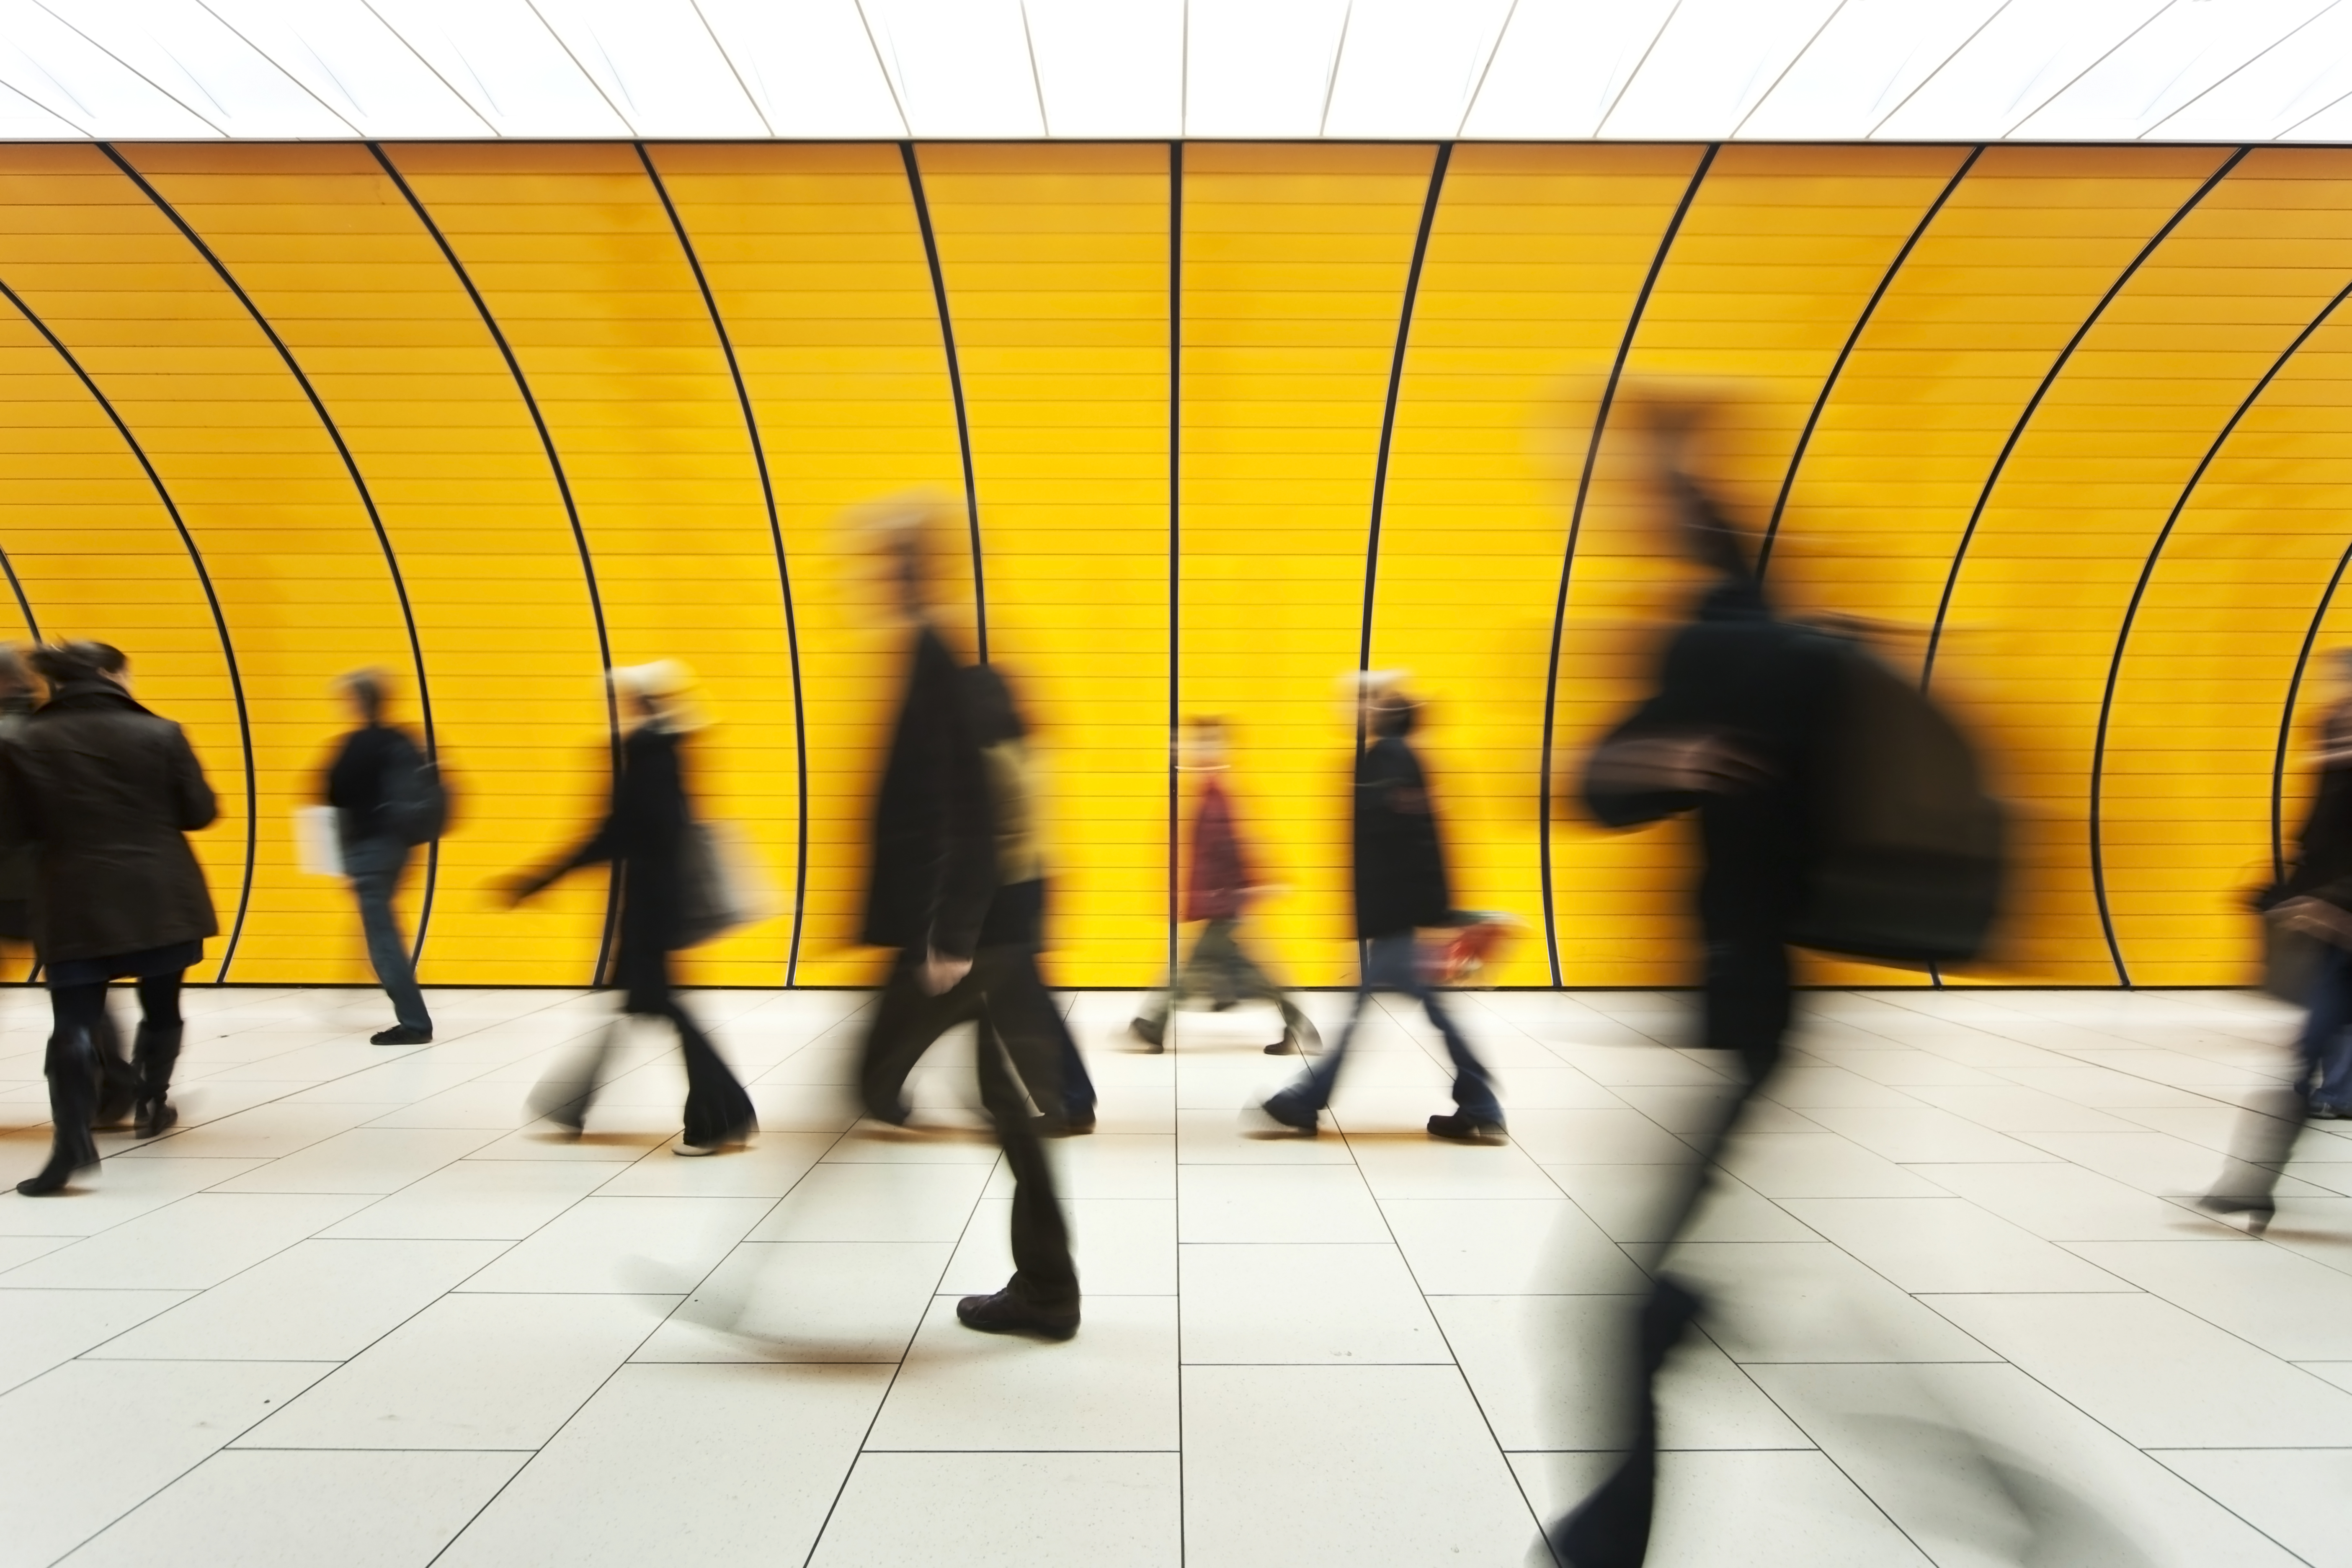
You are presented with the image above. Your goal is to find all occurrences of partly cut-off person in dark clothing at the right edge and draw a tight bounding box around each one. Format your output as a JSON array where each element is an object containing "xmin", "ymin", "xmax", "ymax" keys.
[{"xmin": 2197, "ymin": 649, "xmax": 2352, "ymax": 1232}]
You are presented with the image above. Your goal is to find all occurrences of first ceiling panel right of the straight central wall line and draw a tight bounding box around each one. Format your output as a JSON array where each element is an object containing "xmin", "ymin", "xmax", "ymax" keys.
[{"xmin": 1183, "ymin": 0, "xmax": 1348, "ymax": 137}]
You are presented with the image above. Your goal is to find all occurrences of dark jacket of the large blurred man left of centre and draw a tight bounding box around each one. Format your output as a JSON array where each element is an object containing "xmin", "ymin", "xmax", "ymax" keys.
[{"xmin": 861, "ymin": 625, "xmax": 997, "ymax": 957}]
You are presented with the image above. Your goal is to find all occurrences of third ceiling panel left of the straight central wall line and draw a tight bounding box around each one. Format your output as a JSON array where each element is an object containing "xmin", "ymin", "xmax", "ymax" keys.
[{"xmin": 691, "ymin": 0, "xmax": 908, "ymax": 139}]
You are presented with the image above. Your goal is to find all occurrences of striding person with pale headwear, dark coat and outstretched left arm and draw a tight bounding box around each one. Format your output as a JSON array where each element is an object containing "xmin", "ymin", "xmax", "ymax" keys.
[{"xmin": 505, "ymin": 660, "xmax": 760, "ymax": 1154}]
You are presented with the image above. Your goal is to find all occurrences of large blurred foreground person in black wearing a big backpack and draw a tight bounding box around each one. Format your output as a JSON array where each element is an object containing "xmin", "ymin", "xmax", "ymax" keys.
[{"xmin": 1545, "ymin": 411, "xmax": 2001, "ymax": 1568}]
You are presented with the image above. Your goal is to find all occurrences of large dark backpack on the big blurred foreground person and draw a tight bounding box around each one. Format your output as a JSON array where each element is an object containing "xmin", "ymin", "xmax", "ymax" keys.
[{"xmin": 1790, "ymin": 640, "xmax": 2009, "ymax": 964}]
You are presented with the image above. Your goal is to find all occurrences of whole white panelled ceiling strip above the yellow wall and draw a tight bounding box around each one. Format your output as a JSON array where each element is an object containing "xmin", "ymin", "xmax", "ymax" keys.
[{"xmin": 0, "ymin": 0, "xmax": 2352, "ymax": 141}]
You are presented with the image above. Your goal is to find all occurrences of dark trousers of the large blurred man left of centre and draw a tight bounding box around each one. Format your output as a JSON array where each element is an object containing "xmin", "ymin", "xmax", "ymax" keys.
[{"xmin": 859, "ymin": 945, "xmax": 1093, "ymax": 1307}]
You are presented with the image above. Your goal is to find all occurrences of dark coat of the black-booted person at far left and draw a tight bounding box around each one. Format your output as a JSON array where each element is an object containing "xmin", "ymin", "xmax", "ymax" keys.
[{"xmin": 0, "ymin": 679, "xmax": 221, "ymax": 962}]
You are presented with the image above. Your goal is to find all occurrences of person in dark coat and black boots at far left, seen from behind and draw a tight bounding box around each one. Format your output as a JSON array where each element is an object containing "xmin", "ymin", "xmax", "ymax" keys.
[{"xmin": 0, "ymin": 642, "xmax": 221, "ymax": 1197}]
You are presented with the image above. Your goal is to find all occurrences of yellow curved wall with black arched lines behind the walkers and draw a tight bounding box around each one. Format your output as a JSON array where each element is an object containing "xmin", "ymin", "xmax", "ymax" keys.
[{"xmin": 0, "ymin": 143, "xmax": 2352, "ymax": 985}]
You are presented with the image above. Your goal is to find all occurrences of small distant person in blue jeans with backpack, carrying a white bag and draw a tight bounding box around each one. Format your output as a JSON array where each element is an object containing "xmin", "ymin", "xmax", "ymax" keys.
[{"xmin": 325, "ymin": 670, "xmax": 440, "ymax": 1046}]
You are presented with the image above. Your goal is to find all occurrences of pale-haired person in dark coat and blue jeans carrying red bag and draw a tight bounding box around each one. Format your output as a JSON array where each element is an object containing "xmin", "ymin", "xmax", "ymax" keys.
[{"xmin": 1263, "ymin": 684, "xmax": 1503, "ymax": 1142}]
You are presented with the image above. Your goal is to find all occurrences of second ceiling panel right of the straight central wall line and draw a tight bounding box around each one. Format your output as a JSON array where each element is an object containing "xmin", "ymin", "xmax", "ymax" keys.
[{"xmin": 1324, "ymin": 0, "xmax": 1510, "ymax": 139}]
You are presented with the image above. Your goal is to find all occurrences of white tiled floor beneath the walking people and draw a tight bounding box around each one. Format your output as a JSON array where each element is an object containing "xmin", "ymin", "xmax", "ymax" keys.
[{"xmin": 0, "ymin": 990, "xmax": 2352, "ymax": 1568}]
